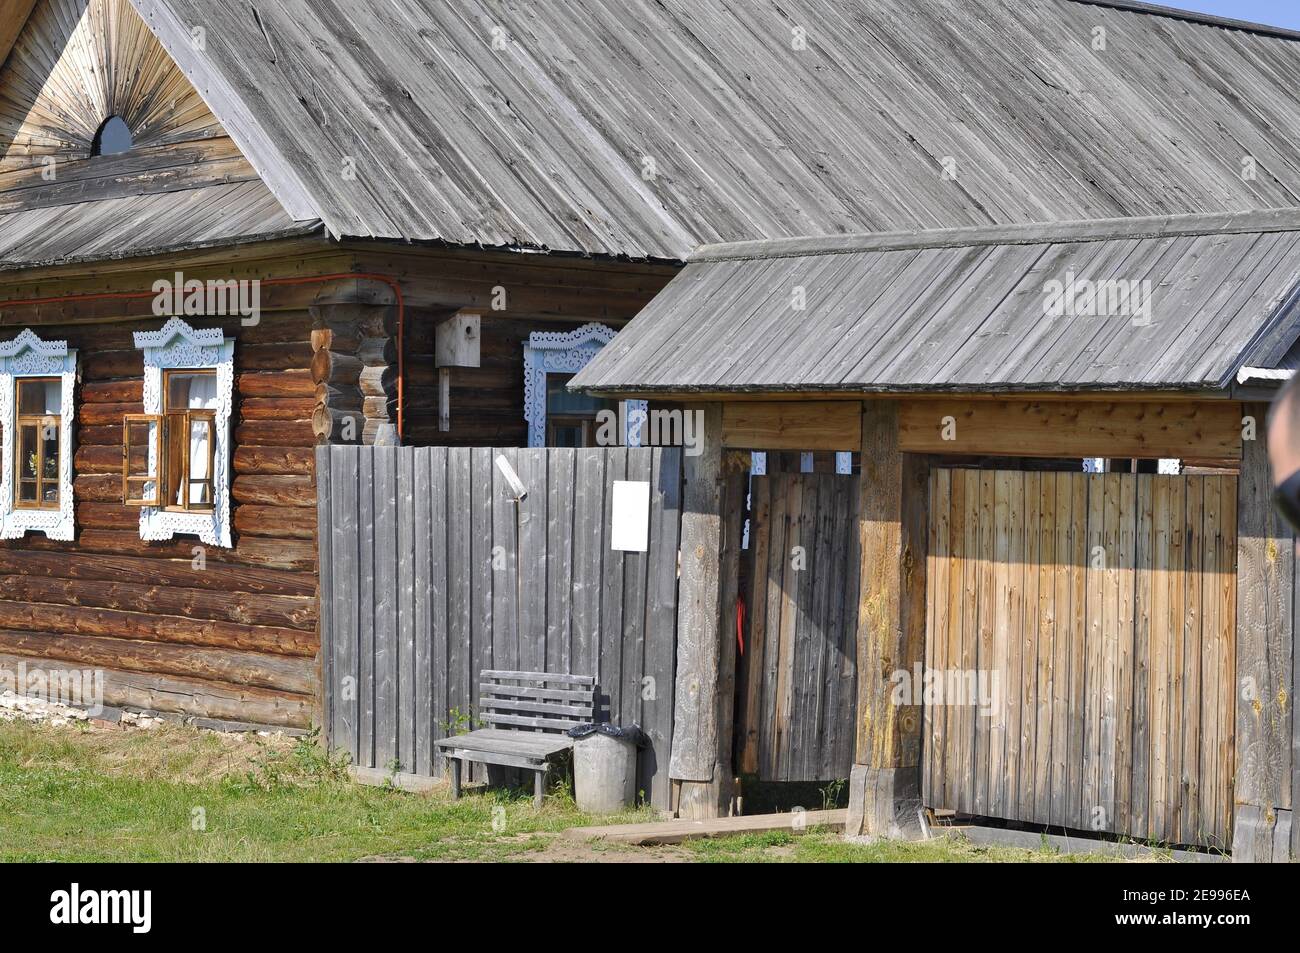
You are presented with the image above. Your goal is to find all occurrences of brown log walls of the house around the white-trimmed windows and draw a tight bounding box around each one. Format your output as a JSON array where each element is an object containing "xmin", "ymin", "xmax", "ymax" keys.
[{"xmin": 0, "ymin": 239, "xmax": 672, "ymax": 728}]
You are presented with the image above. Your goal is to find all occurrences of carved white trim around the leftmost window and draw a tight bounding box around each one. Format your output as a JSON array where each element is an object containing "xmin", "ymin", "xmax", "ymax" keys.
[{"xmin": 0, "ymin": 328, "xmax": 77, "ymax": 542}]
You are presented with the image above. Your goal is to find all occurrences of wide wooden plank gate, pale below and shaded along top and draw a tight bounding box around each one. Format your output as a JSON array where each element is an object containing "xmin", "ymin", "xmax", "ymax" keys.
[{"xmin": 923, "ymin": 469, "xmax": 1236, "ymax": 846}]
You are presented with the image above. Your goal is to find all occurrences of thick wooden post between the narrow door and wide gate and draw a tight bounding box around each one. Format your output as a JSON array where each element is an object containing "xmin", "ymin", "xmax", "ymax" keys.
[{"xmin": 845, "ymin": 400, "xmax": 928, "ymax": 837}]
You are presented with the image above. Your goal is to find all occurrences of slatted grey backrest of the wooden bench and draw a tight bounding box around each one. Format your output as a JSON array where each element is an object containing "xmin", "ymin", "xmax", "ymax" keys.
[{"xmin": 478, "ymin": 670, "xmax": 595, "ymax": 733}]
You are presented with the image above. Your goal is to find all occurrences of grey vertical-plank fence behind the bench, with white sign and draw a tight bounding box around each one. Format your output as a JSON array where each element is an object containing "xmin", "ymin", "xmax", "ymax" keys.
[{"xmin": 317, "ymin": 447, "xmax": 681, "ymax": 809}]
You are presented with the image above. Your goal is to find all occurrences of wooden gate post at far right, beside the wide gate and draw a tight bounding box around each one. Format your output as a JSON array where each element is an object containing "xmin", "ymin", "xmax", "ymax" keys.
[{"xmin": 1232, "ymin": 404, "xmax": 1296, "ymax": 862}]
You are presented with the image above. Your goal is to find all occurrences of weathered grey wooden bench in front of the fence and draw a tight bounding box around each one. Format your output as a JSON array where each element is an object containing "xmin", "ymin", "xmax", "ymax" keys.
[{"xmin": 436, "ymin": 670, "xmax": 595, "ymax": 807}]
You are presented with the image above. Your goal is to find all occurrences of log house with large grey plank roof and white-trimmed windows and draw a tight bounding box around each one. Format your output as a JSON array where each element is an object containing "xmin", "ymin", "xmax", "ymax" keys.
[{"xmin": 0, "ymin": 0, "xmax": 1300, "ymax": 852}]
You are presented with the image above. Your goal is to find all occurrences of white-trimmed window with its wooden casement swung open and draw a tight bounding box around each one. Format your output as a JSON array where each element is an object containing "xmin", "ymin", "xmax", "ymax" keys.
[{"xmin": 122, "ymin": 319, "xmax": 234, "ymax": 546}]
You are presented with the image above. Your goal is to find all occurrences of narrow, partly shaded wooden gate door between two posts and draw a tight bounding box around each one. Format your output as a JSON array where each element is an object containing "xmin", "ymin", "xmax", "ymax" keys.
[{"xmin": 737, "ymin": 473, "xmax": 858, "ymax": 781}]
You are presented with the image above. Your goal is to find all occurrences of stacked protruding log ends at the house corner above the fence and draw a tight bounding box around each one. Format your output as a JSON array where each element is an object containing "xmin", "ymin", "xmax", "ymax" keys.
[{"xmin": 311, "ymin": 278, "xmax": 399, "ymax": 446}]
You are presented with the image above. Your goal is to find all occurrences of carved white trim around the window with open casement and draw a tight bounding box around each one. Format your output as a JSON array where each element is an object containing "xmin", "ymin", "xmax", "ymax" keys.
[{"xmin": 135, "ymin": 317, "xmax": 235, "ymax": 549}]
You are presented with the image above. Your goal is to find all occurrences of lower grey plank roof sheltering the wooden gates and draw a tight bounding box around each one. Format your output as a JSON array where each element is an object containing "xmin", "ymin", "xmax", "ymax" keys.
[{"xmin": 571, "ymin": 209, "xmax": 1300, "ymax": 395}]
